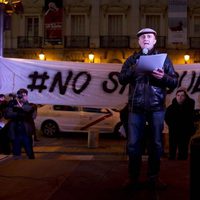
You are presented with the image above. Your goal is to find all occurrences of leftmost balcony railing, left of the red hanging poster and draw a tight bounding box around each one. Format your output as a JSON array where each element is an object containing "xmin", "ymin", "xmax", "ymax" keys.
[{"xmin": 17, "ymin": 36, "xmax": 42, "ymax": 48}]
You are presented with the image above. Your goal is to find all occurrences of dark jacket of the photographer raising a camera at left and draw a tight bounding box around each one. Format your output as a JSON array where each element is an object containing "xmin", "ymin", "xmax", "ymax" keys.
[{"xmin": 5, "ymin": 100, "xmax": 34, "ymax": 139}]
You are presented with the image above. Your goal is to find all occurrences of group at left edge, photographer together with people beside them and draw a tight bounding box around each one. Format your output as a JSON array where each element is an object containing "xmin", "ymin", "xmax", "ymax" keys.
[{"xmin": 0, "ymin": 88, "xmax": 38, "ymax": 159}]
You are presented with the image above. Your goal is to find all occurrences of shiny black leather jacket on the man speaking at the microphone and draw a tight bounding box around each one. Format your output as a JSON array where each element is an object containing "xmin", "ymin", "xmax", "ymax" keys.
[{"xmin": 118, "ymin": 50, "xmax": 178, "ymax": 112}]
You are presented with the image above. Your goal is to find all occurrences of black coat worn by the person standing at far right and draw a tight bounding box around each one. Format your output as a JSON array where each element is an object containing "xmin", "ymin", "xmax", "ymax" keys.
[{"xmin": 165, "ymin": 97, "xmax": 195, "ymax": 136}]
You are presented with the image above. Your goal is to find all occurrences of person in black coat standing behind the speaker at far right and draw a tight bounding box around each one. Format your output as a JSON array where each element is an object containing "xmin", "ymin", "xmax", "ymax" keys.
[{"xmin": 165, "ymin": 87, "xmax": 195, "ymax": 160}]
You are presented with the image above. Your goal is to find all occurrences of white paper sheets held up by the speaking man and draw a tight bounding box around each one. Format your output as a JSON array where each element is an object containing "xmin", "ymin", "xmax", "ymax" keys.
[{"xmin": 136, "ymin": 53, "xmax": 167, "ymax": 72}]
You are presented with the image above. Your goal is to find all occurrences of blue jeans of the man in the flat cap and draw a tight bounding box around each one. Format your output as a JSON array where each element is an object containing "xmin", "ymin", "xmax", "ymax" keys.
[{"xmin": 127, "ymin": 111, "xmax": 165, "ymax": 179}]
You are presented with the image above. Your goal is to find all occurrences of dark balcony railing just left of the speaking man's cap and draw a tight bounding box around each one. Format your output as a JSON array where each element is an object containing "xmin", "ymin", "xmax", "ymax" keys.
[{"xmin": 100, "ymin": 36, "xmax": 130, "ymax": 48}]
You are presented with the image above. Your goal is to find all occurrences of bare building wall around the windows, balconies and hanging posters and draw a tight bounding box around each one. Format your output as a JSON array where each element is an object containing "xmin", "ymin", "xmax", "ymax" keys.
[{"xmin": 4, "ymin": 0, "xmax": 200, "ymax": 64}]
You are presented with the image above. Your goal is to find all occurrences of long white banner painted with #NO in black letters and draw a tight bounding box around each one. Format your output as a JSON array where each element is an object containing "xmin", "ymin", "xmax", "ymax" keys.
[{"xmin": 0, "ymin": 58, "xmax": 200, "ymax": 108}]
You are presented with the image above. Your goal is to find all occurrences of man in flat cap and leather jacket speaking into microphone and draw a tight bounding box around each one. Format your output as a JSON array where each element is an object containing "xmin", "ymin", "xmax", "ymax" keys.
[{"xmin": 119, "ymin": 28, "xmax": 178, "ymax": 189}]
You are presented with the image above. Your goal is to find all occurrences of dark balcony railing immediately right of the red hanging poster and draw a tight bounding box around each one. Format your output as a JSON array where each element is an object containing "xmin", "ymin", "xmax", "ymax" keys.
[{"xmin": 64, "ymin": 36, "xmax": 89, "ymax": 48}]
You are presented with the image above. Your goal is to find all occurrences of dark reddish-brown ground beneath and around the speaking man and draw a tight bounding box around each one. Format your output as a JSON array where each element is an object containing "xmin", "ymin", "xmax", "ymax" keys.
[{"xmin": 0, "ymin": 133, "xmax": 190, "ymax": 200}]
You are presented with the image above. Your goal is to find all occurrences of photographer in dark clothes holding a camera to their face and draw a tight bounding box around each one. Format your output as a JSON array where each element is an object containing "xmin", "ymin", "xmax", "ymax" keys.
[{"xmin": 5, "ymin": 88, "xmax": 35, "ymax": 159}]
